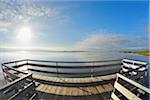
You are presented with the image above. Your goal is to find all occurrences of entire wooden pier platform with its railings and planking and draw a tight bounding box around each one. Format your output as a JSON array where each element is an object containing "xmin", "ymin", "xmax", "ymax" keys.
[{"xmin": 0, "ymin": 60, "xmax": 150, "ymax": 100}]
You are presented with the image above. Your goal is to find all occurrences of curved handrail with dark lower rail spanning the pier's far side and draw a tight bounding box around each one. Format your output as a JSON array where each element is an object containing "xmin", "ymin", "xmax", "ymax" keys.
[{"xmin": 2, "ymin": 59, "xmax": 121, "ymax": 77}]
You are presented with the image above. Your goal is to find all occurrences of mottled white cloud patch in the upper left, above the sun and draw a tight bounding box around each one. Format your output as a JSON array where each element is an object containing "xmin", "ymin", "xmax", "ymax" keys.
[{"xmin": 0, "ymin": 0, "xmax": 58, "ymax": 32}]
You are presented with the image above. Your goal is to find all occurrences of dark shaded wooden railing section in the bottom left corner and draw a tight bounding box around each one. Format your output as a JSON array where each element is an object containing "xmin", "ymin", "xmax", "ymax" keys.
[{"xmin": 0, "ymin": 74, "xmax": 36, "ymax": 100}]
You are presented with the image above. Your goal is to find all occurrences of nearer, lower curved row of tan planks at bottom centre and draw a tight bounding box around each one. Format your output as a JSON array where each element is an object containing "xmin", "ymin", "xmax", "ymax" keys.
[{"xmin": 36, "ymin": 84, "xmax": 113, "ymax": 96}]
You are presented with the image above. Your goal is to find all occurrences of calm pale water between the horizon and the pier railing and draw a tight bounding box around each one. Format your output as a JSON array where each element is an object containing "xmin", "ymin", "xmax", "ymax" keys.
[{"xmin": 0, "ymin": 50, "xmax": 149, "ymax": 86}]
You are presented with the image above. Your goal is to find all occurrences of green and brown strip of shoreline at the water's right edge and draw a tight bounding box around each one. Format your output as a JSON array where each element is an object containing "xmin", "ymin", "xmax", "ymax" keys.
[{"xmin": 120, "ymin": 50, "xmax": 150, "ymax": 56}]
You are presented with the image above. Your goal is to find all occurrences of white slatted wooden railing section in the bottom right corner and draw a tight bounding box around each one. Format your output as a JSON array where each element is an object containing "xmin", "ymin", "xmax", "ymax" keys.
[{"xmin": 111, "ymin": 74, "xmax": 150, "ymax": 100}]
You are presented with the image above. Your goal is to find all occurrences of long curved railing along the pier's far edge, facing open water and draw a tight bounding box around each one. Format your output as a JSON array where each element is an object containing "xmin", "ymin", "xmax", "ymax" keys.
[{"xmin": 2, "ymin": 59, "xmax": 121, "ymax": 77}]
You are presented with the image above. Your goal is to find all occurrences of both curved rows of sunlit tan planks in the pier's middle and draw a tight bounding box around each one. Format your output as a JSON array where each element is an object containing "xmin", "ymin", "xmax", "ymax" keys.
[{"xmin": 33, "ymin": 74, "xmax": 116, "ymax": 96}]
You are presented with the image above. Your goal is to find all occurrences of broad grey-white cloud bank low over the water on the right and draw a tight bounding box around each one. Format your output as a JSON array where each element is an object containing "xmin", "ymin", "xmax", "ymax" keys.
[{"xmin": 76, "ymin": 33, "xmax": 148, "ymax": 51}]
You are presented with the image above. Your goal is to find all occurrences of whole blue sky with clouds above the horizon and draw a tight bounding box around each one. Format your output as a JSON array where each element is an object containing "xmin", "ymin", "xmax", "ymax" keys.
[{"xmin": 0, "ymin": 0, "xmax": 149, "ymax": 50}]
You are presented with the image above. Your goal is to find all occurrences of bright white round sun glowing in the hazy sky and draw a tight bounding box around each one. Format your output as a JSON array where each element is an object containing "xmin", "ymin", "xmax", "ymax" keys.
[{"xmin": 17, "ymin": 27, "xmax": 33, "ymax": 43}]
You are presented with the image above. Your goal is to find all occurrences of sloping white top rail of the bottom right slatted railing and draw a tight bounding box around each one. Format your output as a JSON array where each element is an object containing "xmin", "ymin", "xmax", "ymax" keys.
[{"xmin": 117, "ymin": 74, "xmax": 150, "ymax": 94}]
